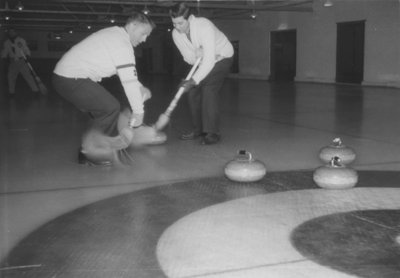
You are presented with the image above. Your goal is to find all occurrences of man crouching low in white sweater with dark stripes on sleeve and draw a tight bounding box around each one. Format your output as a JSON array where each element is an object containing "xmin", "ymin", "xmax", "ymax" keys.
[{"xmin": 53, "ymin": 13, "xmax": 155, "ymax": 165}]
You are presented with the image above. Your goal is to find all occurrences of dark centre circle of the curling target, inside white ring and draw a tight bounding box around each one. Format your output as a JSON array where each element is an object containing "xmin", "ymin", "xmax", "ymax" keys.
[{"xmin": 291, "ymin": 210, "xmax": 400, "ymax": 278}]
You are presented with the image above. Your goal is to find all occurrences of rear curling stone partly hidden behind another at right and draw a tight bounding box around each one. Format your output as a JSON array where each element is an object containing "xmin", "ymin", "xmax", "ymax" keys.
[{"xmin": 319, "ymin": 138, "xmax": 356, "ymax": 165}]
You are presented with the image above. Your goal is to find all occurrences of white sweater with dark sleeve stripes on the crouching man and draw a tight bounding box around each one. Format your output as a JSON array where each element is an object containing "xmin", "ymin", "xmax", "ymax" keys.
[{"xmin": 54, "ymin": 26, "xmax": 144, "ymax": 114}]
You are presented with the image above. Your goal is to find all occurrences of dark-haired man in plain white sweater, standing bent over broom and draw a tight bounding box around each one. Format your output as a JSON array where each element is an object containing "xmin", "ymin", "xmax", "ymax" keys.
[{"xmin": 170, "ymin": 2, "xmax": 234, "ymax": 145}]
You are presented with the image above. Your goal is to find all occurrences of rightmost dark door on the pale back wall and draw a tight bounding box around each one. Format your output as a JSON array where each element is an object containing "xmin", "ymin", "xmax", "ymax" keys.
[{"xmin": 336, "ymin": 21, "xmax": 365, "ymax": 84}]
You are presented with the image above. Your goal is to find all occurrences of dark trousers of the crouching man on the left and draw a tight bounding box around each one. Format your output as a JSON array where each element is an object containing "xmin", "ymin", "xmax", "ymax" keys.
[{"xmin": 52, "ymin": 74, "xmax": 120, "ymax": 136}]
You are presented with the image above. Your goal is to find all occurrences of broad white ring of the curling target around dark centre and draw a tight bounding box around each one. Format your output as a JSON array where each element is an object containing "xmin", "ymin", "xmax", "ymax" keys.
[{"xmin": 157, "ymin": 188, "xmax": 400, "ymax": 278}]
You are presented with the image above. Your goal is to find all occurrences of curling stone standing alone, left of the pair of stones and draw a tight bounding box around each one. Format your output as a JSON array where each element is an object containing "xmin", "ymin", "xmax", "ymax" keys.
[{"xmin": 225, "ymin": 150, "xmax": 267, "ymax": 182}]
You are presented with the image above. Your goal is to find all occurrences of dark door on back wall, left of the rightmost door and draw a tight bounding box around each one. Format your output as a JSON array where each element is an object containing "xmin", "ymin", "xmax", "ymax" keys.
[{"xmin": 270, "ymin": 30, "xmax": 296, "ymax": 81}]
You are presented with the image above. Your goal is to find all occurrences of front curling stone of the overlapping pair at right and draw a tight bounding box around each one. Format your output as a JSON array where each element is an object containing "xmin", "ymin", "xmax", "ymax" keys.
[{"xmin": 313, "ymin": 156, "xmax": 358, "ymax": 189}]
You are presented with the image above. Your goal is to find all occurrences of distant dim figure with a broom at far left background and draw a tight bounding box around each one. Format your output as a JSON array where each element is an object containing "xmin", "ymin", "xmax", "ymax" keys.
[{"xmin": 1, "ymin": 28, "xmax": 39, "ymax": 97}]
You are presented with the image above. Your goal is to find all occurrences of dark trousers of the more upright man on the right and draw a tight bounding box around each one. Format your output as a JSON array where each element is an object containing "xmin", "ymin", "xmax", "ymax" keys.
[{"xmin": 188, "ymin": 58, "xmax": 233, "ymax": 133}]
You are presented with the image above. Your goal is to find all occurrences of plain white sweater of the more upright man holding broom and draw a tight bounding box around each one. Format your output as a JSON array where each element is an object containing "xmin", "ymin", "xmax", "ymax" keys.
[{"xmin": 172, "ymin": 15, "xmax": 234, "ymax": 84}]
